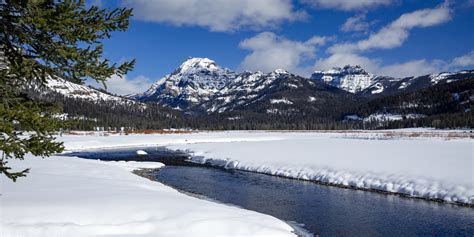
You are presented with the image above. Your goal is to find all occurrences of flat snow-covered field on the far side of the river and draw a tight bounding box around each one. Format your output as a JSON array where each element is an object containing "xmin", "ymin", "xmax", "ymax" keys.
[{"xmin": 47, "ymin": 129, "xmax": 474, "ymax": 204}]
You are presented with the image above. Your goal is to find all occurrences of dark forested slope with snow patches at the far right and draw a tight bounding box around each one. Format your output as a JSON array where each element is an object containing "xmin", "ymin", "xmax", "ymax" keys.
[{"xmin": 352, "ymin": 77, "xmax": 474, "ymax": 128}]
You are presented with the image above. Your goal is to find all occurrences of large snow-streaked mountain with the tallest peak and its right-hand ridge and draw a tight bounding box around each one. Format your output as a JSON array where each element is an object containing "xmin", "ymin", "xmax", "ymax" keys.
[{"xmin": 133, "ymin": 58, "xmax": 358, "ymax": 115}]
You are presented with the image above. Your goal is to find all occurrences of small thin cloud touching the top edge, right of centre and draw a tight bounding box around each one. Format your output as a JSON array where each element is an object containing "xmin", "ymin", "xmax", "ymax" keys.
[{"xmin": 301, "ymin": 0, "xmax": 395, "ymax": 11}]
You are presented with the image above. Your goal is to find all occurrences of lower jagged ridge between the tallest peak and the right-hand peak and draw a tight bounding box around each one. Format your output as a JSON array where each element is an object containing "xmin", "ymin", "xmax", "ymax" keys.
[{"xmin": 201, "ymin": 69, "xmax": 354, "ymax": 118}]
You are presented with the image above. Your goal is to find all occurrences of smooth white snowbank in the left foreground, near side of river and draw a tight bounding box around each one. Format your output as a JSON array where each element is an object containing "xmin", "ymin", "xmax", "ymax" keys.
[{"xmin": 0, "ymin": 157, "xmax": 294, "ymax": 237}]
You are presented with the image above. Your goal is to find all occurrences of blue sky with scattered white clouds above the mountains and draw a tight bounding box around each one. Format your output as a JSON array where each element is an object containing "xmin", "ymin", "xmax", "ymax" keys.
[{"xmin": 85, "ymin": 0, "xmax": 474, "ymax": 94}]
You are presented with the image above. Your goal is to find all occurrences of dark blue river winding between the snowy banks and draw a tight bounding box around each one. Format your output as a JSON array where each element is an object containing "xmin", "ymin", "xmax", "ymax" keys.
[{"xmin": 65, "ymin": 148, "xmax": 474, "ymax": 236}]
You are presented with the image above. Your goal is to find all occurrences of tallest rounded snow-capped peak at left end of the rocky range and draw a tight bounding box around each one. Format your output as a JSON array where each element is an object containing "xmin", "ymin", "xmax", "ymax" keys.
[{"xmin": 132, "ymin": 58, "xmax": 236, "ymax": 109}]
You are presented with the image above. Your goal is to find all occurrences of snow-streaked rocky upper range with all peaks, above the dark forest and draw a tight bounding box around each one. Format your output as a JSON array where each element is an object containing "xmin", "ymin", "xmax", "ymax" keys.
[{"xmin": 132, "ymin": 58, "xmax": 474, "ymax": 120}]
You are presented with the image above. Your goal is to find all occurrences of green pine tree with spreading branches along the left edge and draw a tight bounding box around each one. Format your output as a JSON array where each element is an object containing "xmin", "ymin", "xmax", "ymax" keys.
[{"xmin": 0, "ymin": 0, "xmax": 134, "ymax": 181}]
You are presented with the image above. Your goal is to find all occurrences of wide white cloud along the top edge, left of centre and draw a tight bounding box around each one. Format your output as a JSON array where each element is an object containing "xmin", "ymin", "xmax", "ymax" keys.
[{"xmin": 122, "ymin": 0, "xmax": 306, "ymax": 32}]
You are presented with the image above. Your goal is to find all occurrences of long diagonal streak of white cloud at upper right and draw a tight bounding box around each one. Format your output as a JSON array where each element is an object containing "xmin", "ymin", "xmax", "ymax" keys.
[{"xmin": 329, "ymin": 3, "xmax": 451, "ymax": 53}]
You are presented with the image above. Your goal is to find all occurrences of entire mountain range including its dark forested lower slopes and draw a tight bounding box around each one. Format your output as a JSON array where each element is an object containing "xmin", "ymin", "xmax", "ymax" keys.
[{"xmin": 27, "ymin": 58, "xmax": 474, "ymax": 129}]
